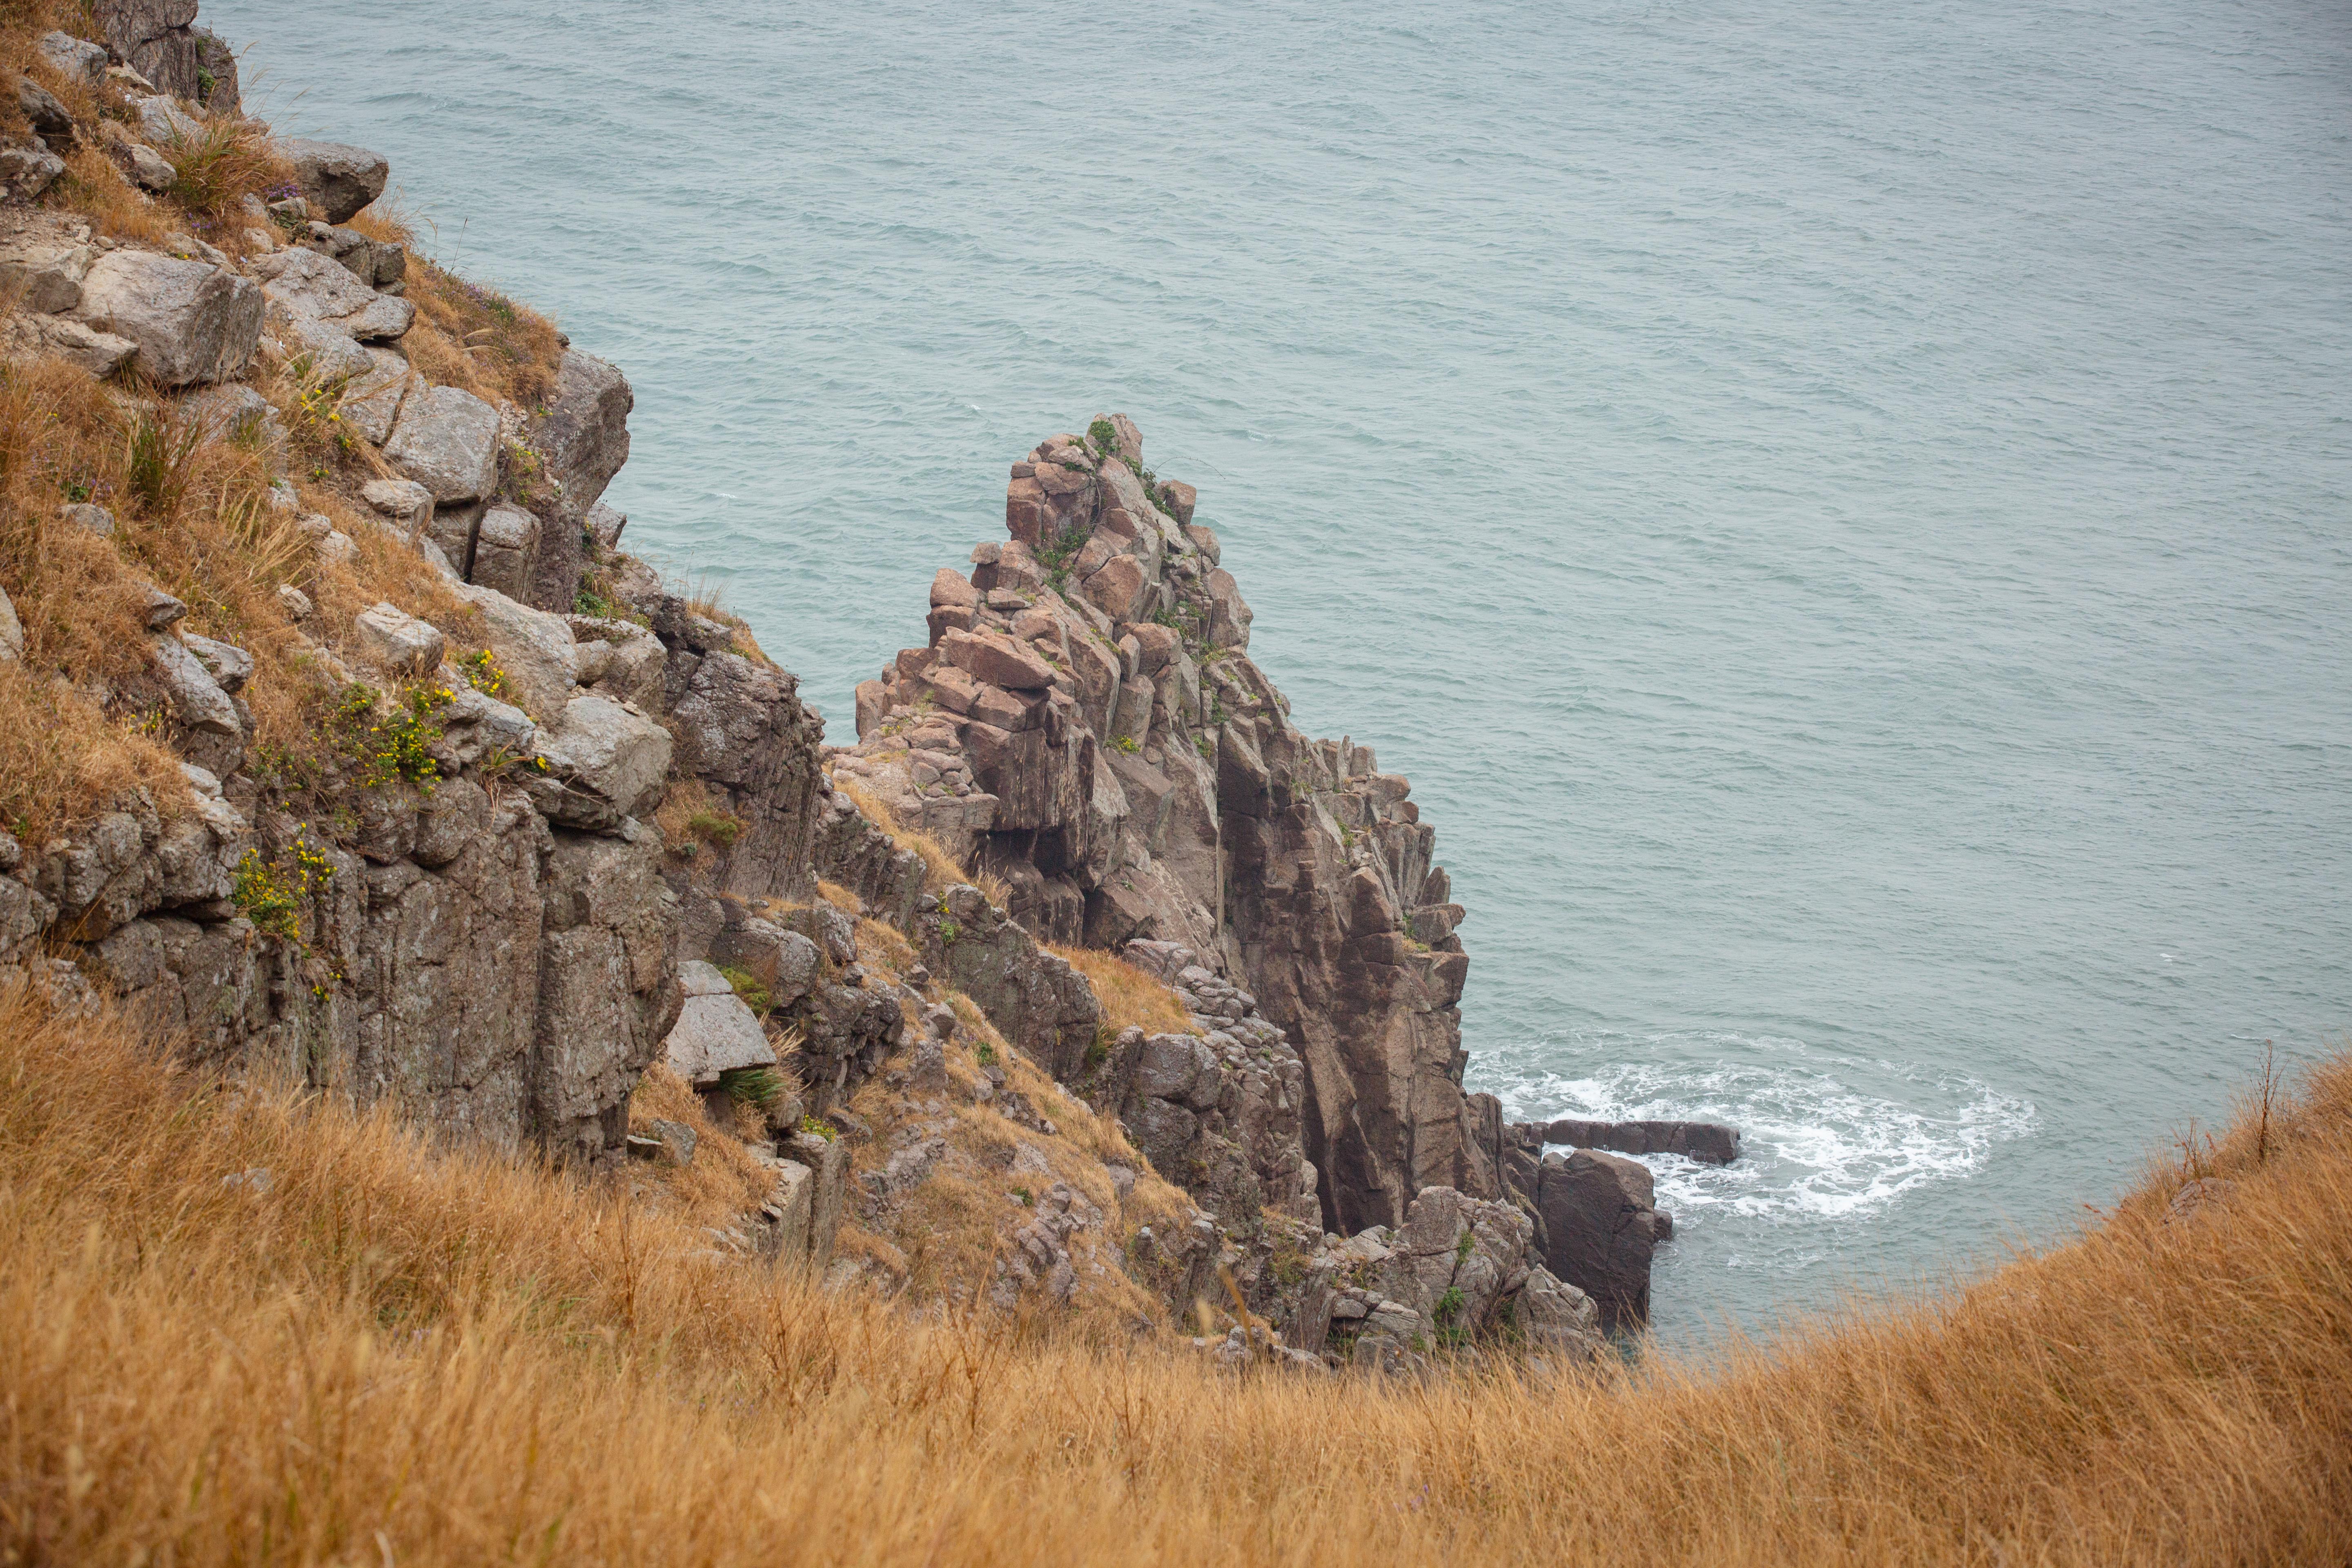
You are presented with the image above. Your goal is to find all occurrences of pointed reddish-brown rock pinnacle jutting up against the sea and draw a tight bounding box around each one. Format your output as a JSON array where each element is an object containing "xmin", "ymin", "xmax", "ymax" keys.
[{"xmin": 835, "ymin": 416, "xmax": 1501, "ymax": 1234}]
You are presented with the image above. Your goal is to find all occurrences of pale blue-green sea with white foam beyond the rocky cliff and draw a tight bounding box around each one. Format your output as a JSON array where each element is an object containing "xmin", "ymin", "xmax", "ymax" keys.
[{"xmin": 205, "ymin": 0, "xmax": 2352, "ymax": 1347}]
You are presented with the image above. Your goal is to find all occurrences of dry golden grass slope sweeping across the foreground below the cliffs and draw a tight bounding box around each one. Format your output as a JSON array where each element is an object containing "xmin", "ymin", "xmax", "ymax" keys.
[{"xmin": 0, "ymin": 997, "xmax": 2352, "ymax": 1566}]
